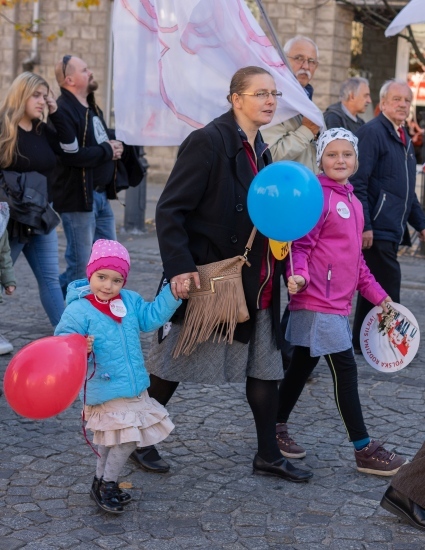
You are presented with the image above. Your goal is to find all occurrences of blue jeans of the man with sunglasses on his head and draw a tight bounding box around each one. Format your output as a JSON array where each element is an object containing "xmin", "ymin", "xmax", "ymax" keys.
[{"xmin": 59, "ymin": 191, "xmax": 117, "ymax": 295}]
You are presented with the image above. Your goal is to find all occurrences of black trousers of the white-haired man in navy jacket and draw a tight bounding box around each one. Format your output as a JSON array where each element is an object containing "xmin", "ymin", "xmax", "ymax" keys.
[{"xmin": 353, "ymin": 240, "xmax": 401, "ymax": 349}]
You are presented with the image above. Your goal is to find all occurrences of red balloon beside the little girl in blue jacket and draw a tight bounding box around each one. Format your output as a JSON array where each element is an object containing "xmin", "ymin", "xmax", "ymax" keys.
[{"xmin": 3, "ymin": 334, "xmax": 87, "ymax": 420}]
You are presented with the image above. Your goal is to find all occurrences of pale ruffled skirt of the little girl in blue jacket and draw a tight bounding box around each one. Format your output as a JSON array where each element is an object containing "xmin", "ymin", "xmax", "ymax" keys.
[{"xmin": 84, "ymin": 391, "xmax": 174, "ymax": 447}]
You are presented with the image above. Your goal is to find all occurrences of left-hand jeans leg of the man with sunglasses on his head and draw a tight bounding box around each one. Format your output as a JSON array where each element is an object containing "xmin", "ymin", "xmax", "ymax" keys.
[{"xmin": 59, "ymin": 212, "xmax": 96, "ymax": 296}]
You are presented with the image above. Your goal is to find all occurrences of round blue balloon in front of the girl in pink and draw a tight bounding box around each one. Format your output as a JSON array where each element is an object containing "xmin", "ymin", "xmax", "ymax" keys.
[{"xmin": 248, "ymin": 160, "xmax": 323, "ymax": 241}]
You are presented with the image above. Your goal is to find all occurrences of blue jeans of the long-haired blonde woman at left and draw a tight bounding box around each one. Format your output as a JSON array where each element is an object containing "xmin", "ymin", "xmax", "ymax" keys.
[{"xmin": 10, "ymin": 229, "xmax": 64, "ymax": 327}]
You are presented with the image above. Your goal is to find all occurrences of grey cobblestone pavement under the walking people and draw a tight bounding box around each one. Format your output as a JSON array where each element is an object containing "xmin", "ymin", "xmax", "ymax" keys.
[{"xmin": 0, "ymin": 186, "xmax": 425, "ymax": 550}]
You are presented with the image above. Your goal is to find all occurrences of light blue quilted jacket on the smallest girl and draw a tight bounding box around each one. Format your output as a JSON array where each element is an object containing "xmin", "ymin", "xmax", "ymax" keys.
[{"xmin": 55, "ymin": 279, "xmax": 181, "ymax": 405}]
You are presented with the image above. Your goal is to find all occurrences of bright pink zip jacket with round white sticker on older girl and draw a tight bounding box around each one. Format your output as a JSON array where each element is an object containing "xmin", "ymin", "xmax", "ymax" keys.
[{"xmin": 286, "ymin": 174, "xmax": 387, "ymax": 315}]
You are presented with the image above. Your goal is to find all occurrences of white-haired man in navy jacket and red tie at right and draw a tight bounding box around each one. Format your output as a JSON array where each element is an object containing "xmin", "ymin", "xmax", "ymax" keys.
[{"xmin": 350, "ymin": 80, "xmax": 425, "ymax": 352}]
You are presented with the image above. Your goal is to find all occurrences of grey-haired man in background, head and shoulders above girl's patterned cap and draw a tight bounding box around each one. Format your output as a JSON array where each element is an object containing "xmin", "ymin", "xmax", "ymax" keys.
[{"xmin": 323, "ymin": 77, "xmax": 371, "ymax": 134}]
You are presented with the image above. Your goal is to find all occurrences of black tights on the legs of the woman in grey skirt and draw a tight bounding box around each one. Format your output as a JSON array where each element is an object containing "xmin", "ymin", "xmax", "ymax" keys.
[{"xmin": 148, "ymin": 374, "xmax": 282, "ymax": 462}]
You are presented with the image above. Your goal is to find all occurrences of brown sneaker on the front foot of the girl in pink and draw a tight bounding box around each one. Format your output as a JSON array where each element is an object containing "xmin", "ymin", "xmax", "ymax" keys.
[{"xmin": 354, "ymin": 439, "xmax": 409, "ymax": 476}]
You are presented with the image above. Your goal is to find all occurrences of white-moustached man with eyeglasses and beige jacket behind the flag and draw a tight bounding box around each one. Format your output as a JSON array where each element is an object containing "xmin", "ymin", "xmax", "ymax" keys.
[{"xmin": 261, "ymin": 36, "xmax": 320, "ymax": 173}]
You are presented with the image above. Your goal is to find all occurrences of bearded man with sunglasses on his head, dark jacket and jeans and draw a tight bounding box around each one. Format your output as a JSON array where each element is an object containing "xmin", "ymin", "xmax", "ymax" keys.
[{"xmin": 52, "ymin": 55, "xmax": 124, "ymax": 293}]
